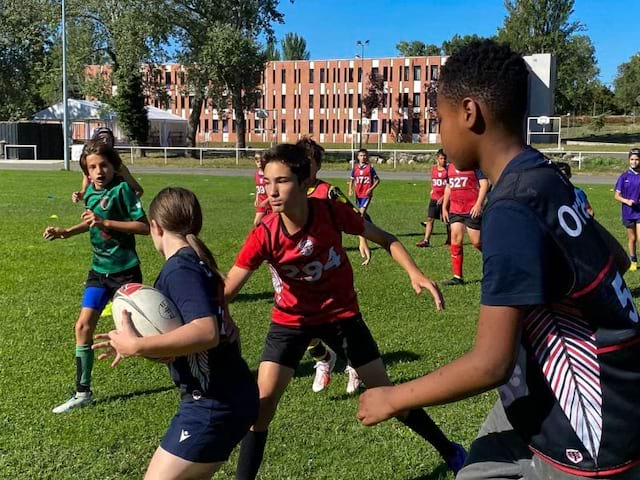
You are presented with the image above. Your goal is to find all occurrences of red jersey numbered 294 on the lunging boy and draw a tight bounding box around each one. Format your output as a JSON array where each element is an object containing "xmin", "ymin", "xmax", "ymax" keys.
[{"xmin": 235, "ymin": 198, "xmax": 364, "ymax": 326}]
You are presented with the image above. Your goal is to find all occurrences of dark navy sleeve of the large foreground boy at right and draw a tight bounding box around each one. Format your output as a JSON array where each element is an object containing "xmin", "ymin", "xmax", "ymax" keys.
[{"xmin": 481, "ymin": 201, "xmax": 572, "ymax": 306}]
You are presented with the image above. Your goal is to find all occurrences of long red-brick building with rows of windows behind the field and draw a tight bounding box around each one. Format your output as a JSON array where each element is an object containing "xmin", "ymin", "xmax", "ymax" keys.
[{"xmin": 88, "ymin": 54, "xmax": 555, "ymax": 144}]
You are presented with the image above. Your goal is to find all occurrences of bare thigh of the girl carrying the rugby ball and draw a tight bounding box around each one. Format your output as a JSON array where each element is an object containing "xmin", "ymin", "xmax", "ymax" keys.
[{"xmin": 144, "ymin": 447, "xmax": 224, "ymax": 480}]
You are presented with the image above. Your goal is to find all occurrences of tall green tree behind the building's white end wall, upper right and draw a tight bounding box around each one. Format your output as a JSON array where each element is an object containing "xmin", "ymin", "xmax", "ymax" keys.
[{"xmin": 498, "ymin": 0, "xmax": 598, "ymax": 113}]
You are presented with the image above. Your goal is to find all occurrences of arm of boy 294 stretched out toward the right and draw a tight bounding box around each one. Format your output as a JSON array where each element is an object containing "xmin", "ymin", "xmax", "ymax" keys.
[{"xmin": 362, "ymin": 221, "xmax": 444, "ymax": 310}]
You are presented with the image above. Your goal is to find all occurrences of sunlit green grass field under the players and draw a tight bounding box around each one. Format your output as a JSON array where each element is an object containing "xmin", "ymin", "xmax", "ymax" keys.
[{"xmin": 0, "ymin": 171, "xmax": 640, "ymax": 480}]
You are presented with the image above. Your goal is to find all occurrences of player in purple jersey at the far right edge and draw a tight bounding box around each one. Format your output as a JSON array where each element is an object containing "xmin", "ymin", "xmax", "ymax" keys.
[{"xmin": 614, "ymin": 148, "xmax": 640, "ymax": 272}]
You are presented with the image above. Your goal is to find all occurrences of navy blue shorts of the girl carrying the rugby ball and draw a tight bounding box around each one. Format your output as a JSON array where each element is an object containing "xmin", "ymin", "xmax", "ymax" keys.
[{"xmin": 160, "ymin": 390, "xmax": 259, "ymax": 463}]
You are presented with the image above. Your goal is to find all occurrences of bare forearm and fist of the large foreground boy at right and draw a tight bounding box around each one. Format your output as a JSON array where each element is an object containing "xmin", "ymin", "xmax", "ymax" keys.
[{"xmin": 357, "ymin": 305, "xmax": 523, "ymax": 426}]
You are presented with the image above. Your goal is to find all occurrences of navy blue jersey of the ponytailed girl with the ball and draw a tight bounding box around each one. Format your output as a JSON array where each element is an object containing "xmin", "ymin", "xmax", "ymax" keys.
[{"xmin": 155, "ymin": 247, "xmax": 253, "ymax": 401}]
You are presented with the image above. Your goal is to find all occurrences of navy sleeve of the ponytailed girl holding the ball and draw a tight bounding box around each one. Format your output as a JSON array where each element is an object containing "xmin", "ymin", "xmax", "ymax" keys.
[{"xmin": 165, "ymin": 267, "xmax": 219, "ymax": 323}]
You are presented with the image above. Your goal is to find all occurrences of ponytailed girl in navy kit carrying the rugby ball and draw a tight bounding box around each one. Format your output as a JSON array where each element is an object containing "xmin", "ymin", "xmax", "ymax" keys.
[{"xmin": 93, "ymin": 187, "xmax": 258, "ymax": 480}]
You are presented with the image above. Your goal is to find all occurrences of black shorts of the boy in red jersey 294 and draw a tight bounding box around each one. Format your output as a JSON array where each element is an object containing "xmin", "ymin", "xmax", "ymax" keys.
[{"xmin": 260, "ymin": 314, "xmax": 380, "ymax": 370}]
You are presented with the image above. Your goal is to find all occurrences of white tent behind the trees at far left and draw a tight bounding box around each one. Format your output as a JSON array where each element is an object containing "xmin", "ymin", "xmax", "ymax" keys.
[{"xmin": 33, "ymin": 99, "xmax": 188, "ymax": 147}]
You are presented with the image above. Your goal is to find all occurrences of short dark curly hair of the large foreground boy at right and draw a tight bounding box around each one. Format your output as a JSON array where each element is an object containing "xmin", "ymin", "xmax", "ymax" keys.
[{"xmin": 439, "ymin": 40, "xmax": 529, "ymax": 132}]
